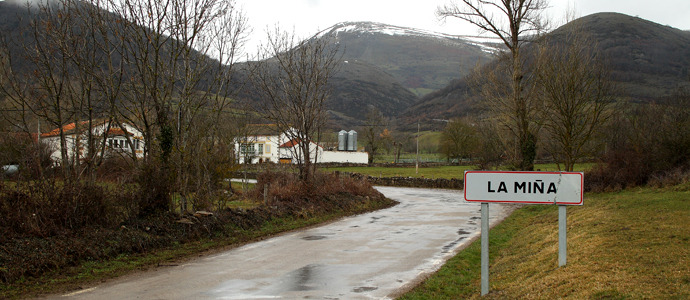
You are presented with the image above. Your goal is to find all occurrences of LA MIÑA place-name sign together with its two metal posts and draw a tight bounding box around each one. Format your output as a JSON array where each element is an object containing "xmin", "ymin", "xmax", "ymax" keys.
[{"xmin": 464, "ymin": 171, "xmax": 584, "ymax": 296}]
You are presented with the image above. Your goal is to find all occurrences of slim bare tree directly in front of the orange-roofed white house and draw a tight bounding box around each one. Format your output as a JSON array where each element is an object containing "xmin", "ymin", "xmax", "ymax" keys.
[{"xmin": 59, "ymin": 0, "xmax": 130, "ymax": 181}]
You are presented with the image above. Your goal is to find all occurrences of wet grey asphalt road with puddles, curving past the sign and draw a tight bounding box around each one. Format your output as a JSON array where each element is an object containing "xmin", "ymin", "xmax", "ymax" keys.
[{"xmin": 56, "ymin": 187, "xmax": 509, "ymax": 299}]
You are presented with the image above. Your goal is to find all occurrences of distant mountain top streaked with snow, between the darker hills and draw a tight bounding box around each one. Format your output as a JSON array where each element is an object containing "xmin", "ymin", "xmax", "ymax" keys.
[{"xmin": 315, "ymin": 22, "xmax": 496, "ymax": 96}]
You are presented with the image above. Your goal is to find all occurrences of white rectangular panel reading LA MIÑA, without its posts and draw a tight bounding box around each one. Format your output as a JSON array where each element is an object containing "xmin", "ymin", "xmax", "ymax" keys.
[{"xmin": 464, "ymin": 171, "xmax": 584, "ymax": 205}]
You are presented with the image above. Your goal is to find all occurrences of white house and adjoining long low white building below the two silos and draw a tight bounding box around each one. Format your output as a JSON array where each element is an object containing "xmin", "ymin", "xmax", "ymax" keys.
[{"xmin": 235, "ymin": 124, "xmax": 369, "ymax": 164}]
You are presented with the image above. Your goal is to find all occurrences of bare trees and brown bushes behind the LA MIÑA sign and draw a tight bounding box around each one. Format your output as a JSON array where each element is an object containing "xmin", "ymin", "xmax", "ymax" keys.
[{"xmin": 437, "ymin": 0, "xmax": 690, "ymax": 187}]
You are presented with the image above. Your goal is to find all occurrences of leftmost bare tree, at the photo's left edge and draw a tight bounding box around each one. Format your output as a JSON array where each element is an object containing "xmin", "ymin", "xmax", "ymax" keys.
[{"xmin": 2, "ymin": 2, "xmax": 84, "ymax": 179}]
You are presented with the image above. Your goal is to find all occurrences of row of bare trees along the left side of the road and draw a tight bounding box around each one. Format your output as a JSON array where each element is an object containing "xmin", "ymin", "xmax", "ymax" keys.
[{"xmin": 0, "ymin": 0, "xmax": 338, "ymax": 212}]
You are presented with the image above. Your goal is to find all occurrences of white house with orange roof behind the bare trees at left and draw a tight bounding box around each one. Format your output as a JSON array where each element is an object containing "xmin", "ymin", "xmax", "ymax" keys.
[{"xmin": 40, "ymin": 120, "xmax": 144, "ymax": 162}]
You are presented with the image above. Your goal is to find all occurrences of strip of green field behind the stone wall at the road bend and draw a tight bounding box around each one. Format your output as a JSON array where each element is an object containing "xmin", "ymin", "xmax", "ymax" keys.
[{"xmin": 322, "ymin": 163, "xmax": 594, "ymax": 179}]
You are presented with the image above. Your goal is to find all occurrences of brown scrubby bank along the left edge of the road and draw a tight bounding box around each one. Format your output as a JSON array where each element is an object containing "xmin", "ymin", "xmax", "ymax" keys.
[{"xmin": 0, "ymin": 172, "xmax": 393, "ymax": 285}]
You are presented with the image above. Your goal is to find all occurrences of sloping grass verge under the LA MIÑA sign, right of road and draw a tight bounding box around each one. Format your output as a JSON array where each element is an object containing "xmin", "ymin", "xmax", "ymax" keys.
[{"xmin": 400, "ymin": 184, "xmax": 690, "ymax": 299}]
